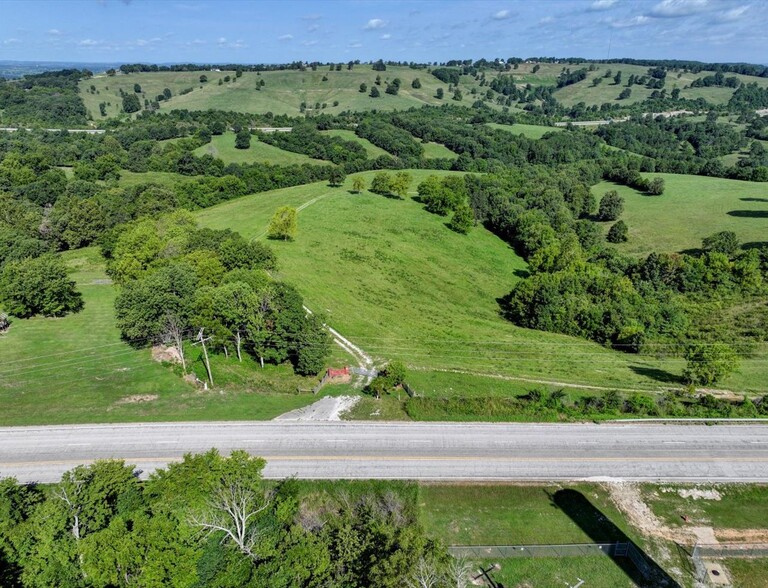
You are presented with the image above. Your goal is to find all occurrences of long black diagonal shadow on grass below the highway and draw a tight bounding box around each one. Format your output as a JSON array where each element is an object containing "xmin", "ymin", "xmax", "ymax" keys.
[{"xmin": 552, "ymin": 489, "xmax": 680, "ymax": 588}]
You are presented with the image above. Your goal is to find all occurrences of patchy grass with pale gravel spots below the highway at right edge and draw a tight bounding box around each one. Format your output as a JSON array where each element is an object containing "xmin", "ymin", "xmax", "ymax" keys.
[{"xmin": 642, "ymin": 484, "xmax": 768, "ymax": 534}]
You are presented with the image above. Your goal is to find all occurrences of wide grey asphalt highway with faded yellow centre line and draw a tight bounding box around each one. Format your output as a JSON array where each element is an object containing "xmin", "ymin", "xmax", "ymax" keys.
[{"xmin": 0, "ymin": 421, "xmax": 768, "ymax": 482}]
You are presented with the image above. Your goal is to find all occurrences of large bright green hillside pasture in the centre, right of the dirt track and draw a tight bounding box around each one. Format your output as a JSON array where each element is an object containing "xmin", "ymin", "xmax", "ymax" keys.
[{"xmin": 198, "ymin": 175, "xmax": 732, "ymax": 395}]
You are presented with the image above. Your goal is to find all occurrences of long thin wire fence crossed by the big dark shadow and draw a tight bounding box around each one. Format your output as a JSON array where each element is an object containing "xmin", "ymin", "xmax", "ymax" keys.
[{"xmin": 448, "ymin": 543, "xmax": 628, "ymax": 561}]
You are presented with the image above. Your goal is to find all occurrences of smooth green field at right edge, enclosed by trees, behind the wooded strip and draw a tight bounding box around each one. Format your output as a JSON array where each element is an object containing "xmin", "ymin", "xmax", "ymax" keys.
[{"xmin": 592, "ymin": 174, "xmax": 768, "ymax": 255}]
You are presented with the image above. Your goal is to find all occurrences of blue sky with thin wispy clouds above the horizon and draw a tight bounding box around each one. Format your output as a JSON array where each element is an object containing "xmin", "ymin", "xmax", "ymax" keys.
[{"xmin": 0, "ymin": 0, "xmax": 768, "ymax": 63}]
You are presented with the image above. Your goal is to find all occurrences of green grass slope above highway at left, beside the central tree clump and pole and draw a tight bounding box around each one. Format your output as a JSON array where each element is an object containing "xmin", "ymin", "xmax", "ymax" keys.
[{"xmin": 0, "ymin": 248, "xmax": 328, "ymax": 425}]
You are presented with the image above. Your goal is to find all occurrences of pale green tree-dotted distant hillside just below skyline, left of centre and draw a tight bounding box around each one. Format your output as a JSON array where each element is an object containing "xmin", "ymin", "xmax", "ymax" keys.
[{"xmin": 80, "ymin": 64, "xmax": 477, "ymax": 120}]
